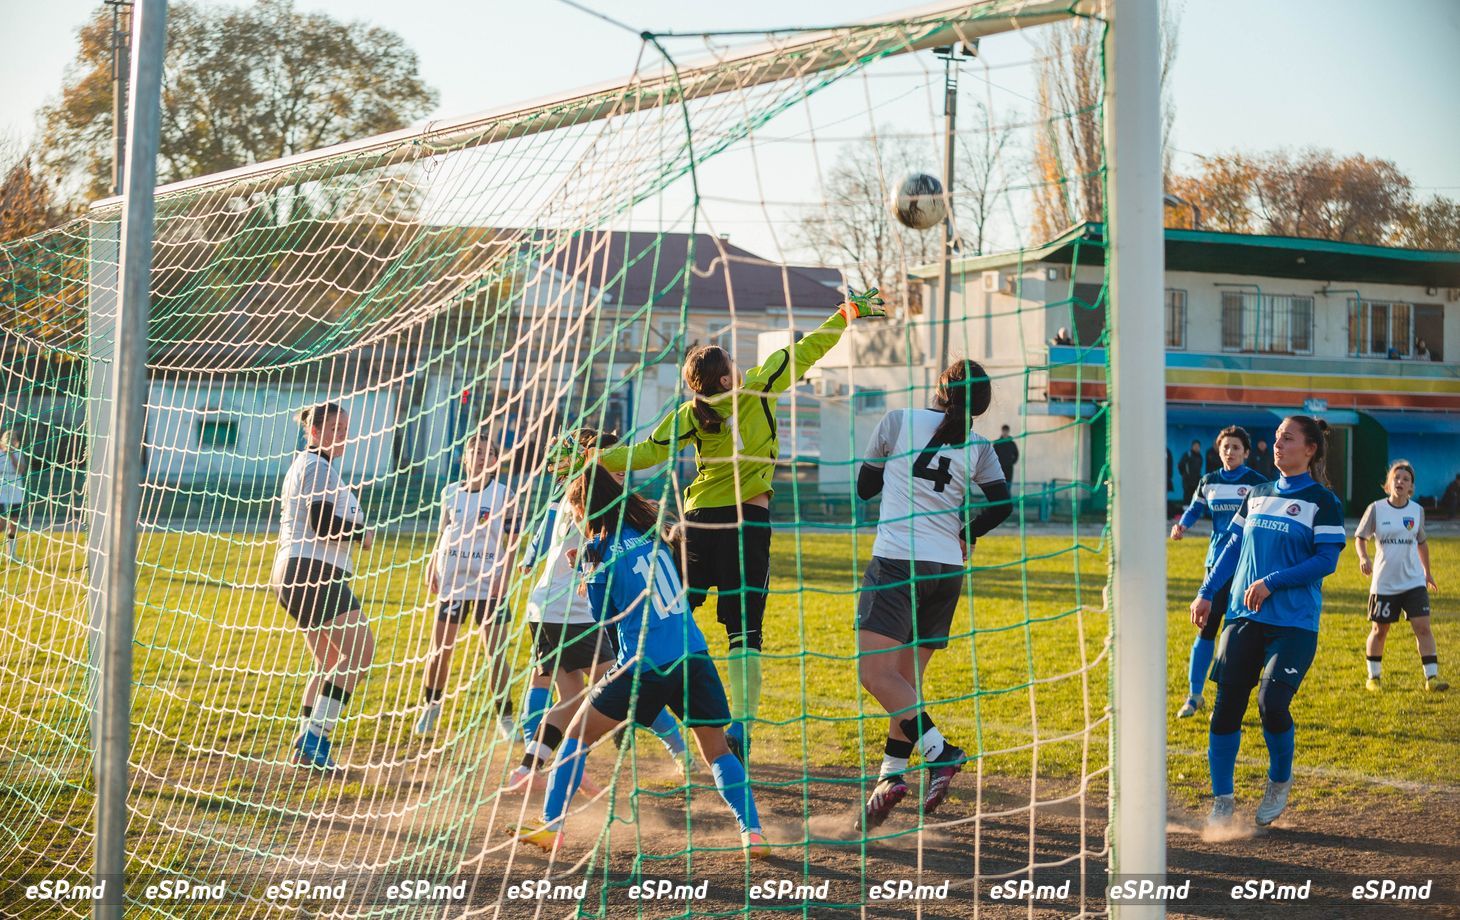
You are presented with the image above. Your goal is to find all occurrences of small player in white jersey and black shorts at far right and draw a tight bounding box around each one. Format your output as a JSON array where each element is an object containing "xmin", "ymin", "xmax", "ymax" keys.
[{"xmin": 1353, "ymin": 460, "xmax": 1450, "ymax": 692}]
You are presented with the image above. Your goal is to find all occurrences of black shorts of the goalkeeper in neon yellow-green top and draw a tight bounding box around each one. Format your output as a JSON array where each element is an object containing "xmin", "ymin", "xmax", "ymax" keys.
[{"xmin": 685, "ymin": 505, "xmax": 771, "ymax": 648}]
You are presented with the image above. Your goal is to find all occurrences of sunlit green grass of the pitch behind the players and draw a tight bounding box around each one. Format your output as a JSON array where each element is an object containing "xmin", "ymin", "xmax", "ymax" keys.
[{"xmin": 0, "ymin": 527, "xmax": 1460, "ymax": 887}]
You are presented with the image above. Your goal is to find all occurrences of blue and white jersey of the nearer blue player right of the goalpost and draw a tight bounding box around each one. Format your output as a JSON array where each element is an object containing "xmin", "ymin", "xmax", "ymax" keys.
[{"xmin": 1226, "ymin": 473, "xmax": 1343, "ymax": 632}]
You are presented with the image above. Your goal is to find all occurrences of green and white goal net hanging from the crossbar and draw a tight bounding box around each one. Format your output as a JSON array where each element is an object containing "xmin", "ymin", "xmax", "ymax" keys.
[{"xmin": 0, "ymin": 0, "xmax": 1150, "ymax": 917}]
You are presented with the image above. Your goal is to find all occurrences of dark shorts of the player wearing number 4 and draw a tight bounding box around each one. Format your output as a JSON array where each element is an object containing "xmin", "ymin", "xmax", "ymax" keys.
[{"xmin": 857, "ymin": 556, "xmax": 965, "ymax": 648}]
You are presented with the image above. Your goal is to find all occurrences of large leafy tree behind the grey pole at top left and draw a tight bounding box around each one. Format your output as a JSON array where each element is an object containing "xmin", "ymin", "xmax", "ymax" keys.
[{"xmin": 41, "ymin": 0, "xmax": 437, "ymax": 205}]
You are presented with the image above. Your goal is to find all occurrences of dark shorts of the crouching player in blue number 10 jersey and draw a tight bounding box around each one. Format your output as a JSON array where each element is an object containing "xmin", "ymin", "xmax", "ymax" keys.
[{"xmin": 588, "ymin": 653, "xmax": 730, "ymax": 727}]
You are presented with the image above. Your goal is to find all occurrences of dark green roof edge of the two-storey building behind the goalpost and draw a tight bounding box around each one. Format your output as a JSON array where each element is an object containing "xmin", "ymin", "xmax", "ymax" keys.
[{"xmin": 910, "ymin": 222, "xmax": 1460, "ymax": 288}]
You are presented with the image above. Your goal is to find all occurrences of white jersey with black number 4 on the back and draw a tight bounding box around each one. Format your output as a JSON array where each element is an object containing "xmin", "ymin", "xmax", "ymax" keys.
[{"xmin": 866, "ymin": 409, "xmax": 1003, "ymax": 565}]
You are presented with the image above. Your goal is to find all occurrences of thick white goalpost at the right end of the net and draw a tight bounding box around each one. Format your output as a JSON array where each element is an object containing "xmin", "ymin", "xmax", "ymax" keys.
[{"xmin": 1104, "ymin": 0, "xmax": 1167, "ymax": 920}]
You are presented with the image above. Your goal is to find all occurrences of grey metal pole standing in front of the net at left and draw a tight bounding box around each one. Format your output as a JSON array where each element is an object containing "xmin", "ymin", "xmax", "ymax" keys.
[{"xmin": 91, "ymin": 0, "xmax": 168, "ymax": 920}]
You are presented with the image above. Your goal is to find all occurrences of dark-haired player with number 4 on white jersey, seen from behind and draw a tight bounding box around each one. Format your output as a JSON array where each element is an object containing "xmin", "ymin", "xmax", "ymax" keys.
[{"xmin": 857, "ymin": 359, "xmax": 1012, "ymax": 828}]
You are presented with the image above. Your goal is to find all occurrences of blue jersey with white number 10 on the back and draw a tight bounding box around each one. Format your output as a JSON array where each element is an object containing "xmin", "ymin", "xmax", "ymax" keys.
[{"xmin": 587, "ymin": 524, "xmax": 708, "ymax": 672}]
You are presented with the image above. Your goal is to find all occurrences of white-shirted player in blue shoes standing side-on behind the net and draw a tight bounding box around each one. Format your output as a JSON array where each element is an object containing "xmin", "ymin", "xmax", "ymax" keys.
[{"xmin": 270, "ymin": 403, "xmax": 375, "ymax": 770}]
